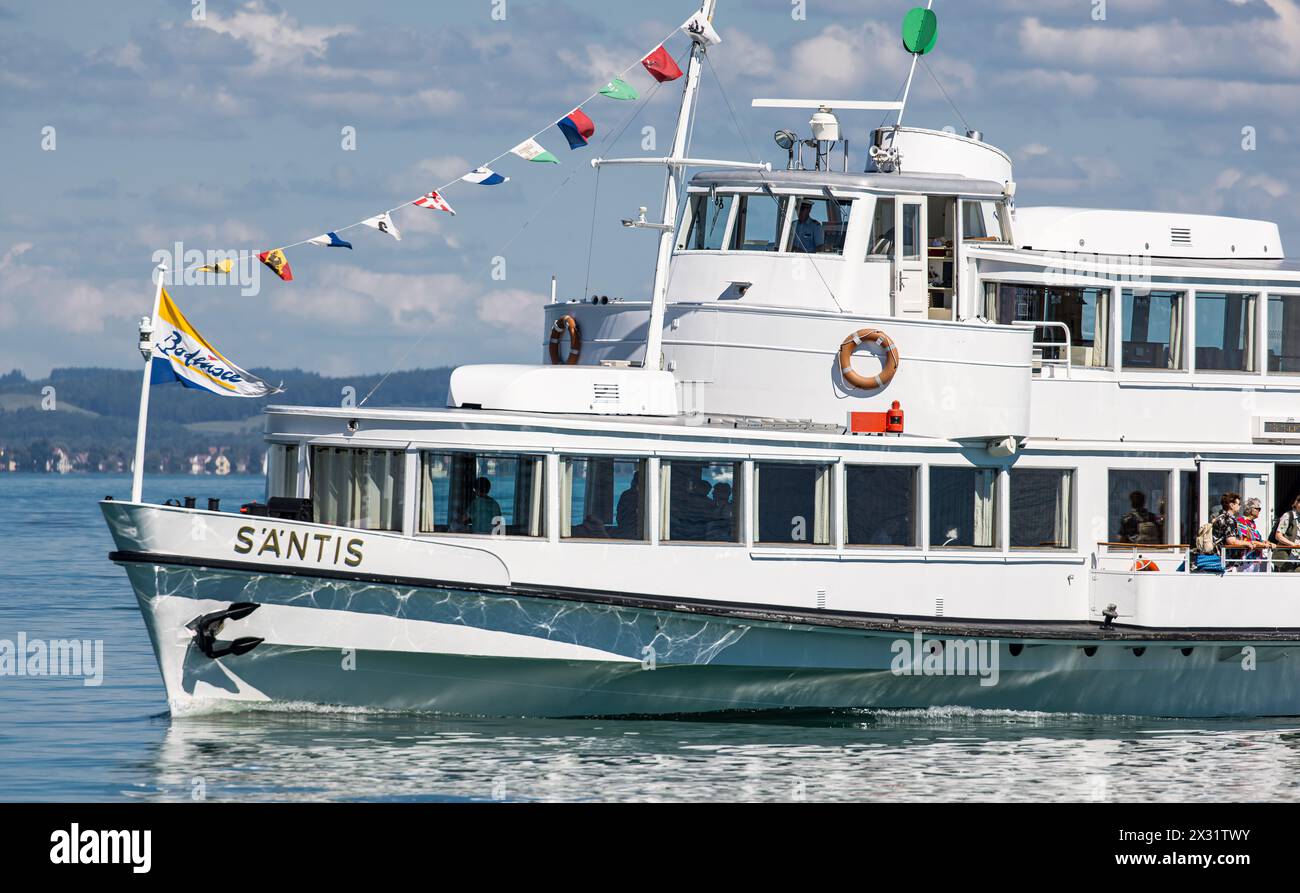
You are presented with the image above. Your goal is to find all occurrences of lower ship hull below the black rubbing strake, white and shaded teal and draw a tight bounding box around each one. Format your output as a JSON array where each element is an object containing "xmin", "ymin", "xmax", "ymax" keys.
[{"xmin": 116, "ymin": 555, "xmax": 1300, "ymax": 716}]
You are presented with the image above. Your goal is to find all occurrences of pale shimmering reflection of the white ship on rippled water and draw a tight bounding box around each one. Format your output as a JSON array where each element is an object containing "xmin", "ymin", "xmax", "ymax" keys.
[{"xmin": 137, "ymin": 710, "xmax": 1300, "ymax": 802}]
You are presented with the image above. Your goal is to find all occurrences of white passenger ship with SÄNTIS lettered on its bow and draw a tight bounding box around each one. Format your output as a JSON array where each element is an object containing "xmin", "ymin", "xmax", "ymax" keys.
[{"xmin": 103, "ymin": 0, "xmax": 1300, "ymax": 716}]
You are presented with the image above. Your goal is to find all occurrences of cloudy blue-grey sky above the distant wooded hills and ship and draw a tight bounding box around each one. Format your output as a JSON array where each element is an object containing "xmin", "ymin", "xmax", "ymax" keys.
[{"xmin": 0, "ymin": 0, "xmax": 1300, "ymax": 376}]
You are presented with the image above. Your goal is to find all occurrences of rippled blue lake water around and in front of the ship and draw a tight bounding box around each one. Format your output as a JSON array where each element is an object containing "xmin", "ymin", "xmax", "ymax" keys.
[{"xmin": 0, "ymin": 474, "xmax": 1300, "ymax": 802}]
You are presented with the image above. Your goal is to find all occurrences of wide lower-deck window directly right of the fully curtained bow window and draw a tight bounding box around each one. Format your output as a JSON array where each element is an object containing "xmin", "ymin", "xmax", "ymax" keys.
[{"xmin": 420, "ymin": 452, "xmax": 546, "ymax": 537}]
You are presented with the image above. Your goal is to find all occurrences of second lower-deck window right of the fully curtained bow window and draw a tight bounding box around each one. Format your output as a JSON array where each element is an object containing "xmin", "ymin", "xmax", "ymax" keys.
[{"xmin": 560, "ymin": 456, "xmax": 647, "ymax": 539}]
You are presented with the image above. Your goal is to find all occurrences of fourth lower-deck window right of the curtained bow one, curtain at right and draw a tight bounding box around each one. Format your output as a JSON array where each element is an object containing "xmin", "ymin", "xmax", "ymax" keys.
[{"xmin": 754, "ymin": 463, "xmax": 831, "ymax": 546}]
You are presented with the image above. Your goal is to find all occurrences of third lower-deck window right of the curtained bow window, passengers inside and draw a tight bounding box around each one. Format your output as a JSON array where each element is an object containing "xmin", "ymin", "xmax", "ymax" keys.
[{"xmin": 659, "ymin": 459, "xmax": 740, "ymax": 542}]
